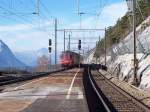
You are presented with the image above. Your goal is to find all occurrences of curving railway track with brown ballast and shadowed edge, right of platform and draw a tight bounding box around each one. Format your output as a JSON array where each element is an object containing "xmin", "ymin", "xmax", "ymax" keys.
[{"xmin": 83, "ymin": 69, "xmax": 150, "ymax": 112}]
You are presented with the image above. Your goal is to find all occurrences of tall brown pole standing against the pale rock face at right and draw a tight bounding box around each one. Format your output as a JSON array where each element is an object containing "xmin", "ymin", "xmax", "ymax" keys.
[{"xmin": 132, "ymin": 0, "xmax": 138, "ymax": 86}]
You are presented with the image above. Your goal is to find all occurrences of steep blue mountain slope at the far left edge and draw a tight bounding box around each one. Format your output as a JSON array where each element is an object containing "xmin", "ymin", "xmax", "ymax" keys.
[{"xmin": 0, "ymin": 40, "xmax": 25, "ymax": 69}]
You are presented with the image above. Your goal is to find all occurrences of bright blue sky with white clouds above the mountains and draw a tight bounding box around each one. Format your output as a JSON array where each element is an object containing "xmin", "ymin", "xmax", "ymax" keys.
[{"xmin": 0, "ymin": 0, "xmax": 127, "ymax": 52}]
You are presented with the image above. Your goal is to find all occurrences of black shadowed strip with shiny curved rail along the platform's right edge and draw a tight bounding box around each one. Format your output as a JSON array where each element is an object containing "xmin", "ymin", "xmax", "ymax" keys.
[{"xmin": 83, "ymin": 69, "xmax": 110, "ymax": 112}]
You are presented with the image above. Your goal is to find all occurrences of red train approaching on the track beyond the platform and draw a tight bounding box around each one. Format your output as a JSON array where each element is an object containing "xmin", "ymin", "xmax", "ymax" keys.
[{"xmin": 60, "ymin": 51, "xmax": 82, "ymax": 67}]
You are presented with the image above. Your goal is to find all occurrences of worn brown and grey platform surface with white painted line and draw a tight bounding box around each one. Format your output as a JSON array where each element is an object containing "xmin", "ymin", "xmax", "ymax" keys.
[{"xmin": 0, "ymin": 69, "xmax": 88, "ymax": 112}]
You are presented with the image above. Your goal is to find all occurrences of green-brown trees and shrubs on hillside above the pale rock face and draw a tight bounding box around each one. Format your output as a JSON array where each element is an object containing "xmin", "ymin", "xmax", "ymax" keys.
[{"xmin": 95, "ymin": 0, "xmax": 150, "ymax": 57}]
